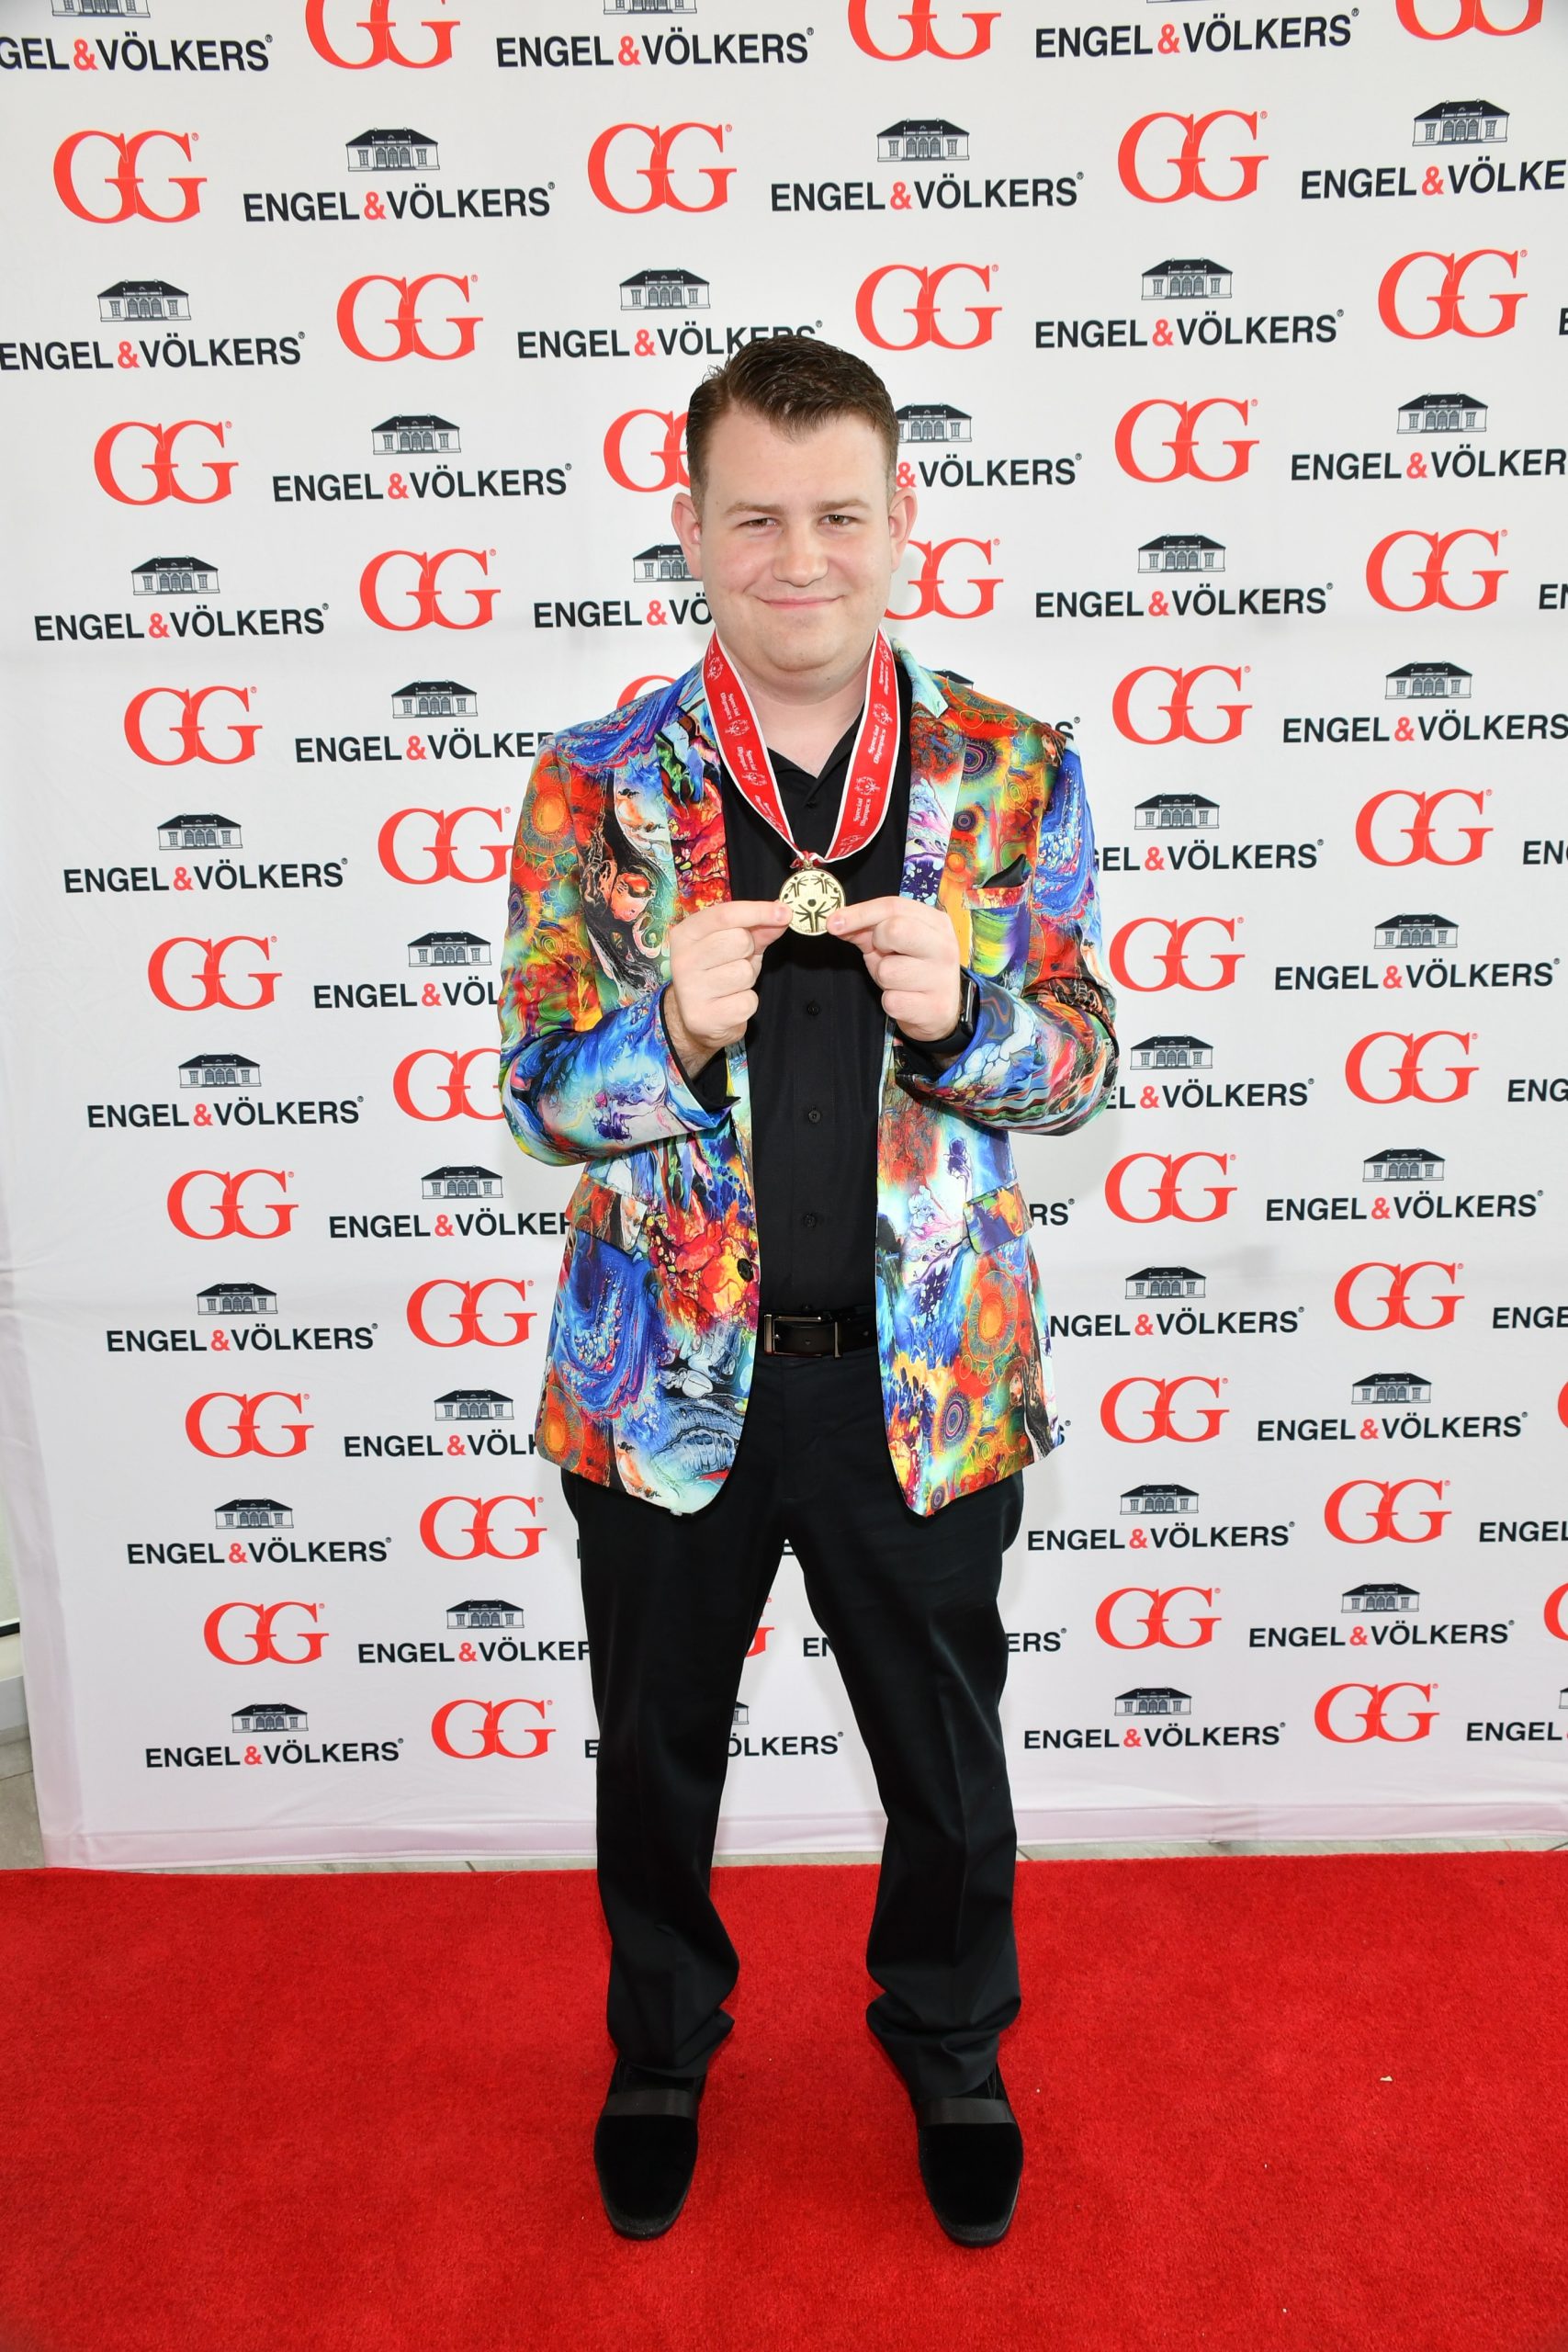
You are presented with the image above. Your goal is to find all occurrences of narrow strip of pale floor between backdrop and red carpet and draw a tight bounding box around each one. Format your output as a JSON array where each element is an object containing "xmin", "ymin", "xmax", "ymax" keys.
[{"xmin": 0, "ymin": 1736, "xmax": 1568, "ymax": 1872}]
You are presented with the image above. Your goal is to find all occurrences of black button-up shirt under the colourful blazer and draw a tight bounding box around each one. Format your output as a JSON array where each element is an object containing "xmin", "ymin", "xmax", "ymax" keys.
[{"xmin": 658, "ymin": 663, "xmax": 974, "ymax": 1315}]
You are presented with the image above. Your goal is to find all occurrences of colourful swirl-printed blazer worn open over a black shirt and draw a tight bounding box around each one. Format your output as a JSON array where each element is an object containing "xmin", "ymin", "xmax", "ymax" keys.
[{"xmin": 501, "ymin": 644, "xmax": 1117, "ymax": 1517}]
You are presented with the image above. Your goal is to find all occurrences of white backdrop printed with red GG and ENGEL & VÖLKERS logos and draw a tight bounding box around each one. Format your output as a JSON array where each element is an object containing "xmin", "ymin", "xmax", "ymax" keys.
[{"xmin": 0, "ymin": 0, "xmax": 1568, "ymax": 1865}]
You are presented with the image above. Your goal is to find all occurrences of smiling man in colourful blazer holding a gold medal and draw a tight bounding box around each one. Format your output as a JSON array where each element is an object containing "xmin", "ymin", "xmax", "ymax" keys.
[{"xmin": 501, "ymin": 336, "xmax": 1117, "ymax": 2244}]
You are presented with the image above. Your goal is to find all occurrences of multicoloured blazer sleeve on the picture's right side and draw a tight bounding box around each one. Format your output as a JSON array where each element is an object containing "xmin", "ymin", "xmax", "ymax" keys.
[{"xmin": 896, "ymin": 729, "xmax": 1119, "ymax": 1136}]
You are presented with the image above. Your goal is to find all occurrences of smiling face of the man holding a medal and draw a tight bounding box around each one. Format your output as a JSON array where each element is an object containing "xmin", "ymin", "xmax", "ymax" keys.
[{"xmin": 672, "ymin": 409, "xmax": 915, "ymax": 701}]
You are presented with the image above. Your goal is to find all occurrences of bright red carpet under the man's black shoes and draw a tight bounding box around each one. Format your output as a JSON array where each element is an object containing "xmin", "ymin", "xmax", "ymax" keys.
[{"xmin": 0, "ymin": 1853, "xmax": 1568, "ymax": 2352}]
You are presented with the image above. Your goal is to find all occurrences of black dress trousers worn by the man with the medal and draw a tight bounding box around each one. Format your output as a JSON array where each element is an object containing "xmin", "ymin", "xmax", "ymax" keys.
[{"xmin": 562, "ymin": 1348, "xmax": 1022, "ymax": 2098}]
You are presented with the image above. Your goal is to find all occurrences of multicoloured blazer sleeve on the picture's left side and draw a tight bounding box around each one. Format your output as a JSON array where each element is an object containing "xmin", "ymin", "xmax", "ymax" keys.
[{"xmin": 499, "ymin": 739, "xmax": 728, "ymax": 1167}]
